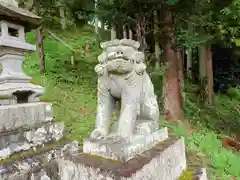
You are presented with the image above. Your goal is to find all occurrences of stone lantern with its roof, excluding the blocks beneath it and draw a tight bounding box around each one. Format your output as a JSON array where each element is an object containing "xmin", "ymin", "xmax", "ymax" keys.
[{"xmin": 0, "ymin": 0, "xmax": 44, "ymax": 105}]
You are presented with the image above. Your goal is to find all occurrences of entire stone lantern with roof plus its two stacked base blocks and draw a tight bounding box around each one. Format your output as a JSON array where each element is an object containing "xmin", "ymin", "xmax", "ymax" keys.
[{"xmin": 0, "ymin": 0, "xmax": 64, "ymax": 165}]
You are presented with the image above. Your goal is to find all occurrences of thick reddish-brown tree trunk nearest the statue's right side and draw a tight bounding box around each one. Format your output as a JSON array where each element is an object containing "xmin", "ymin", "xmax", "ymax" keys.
[{"xmin": 161, "ymin": 10, "xmax": 182, "ymax": 121}]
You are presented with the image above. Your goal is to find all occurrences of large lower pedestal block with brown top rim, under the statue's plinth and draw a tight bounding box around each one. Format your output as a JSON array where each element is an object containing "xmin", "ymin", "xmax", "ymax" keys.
[{"xmin": 58, "ymin": 138, "xmax": 186, "ymax": 180}]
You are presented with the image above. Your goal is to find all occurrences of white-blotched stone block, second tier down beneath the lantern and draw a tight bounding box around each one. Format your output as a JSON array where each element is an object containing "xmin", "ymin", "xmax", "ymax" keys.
[{"xmin": 0, "ymin": 122, "xmax": 64, "ymax": 159}]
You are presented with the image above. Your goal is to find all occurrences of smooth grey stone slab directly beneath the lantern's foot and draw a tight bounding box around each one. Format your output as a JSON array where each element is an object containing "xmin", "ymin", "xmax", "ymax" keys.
[{"xmin": 0, "ymin": 102, "xmax": 53, "ymax": 133}]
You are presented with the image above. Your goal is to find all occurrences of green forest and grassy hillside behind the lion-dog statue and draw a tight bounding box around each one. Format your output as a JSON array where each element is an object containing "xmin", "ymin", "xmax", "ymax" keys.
[{"xmin": 14, "ymin": 0, "xmax": 240, "ymax": 179}]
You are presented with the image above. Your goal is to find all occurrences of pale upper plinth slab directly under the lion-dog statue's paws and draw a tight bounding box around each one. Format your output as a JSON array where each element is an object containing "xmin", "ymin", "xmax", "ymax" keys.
[{"xmin": 83, "ymin": 128, "xmax": 168, "ymax": 161}]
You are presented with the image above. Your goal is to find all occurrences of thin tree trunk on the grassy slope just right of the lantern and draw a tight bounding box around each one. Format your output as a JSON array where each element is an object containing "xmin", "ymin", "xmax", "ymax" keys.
[{"xmin": 36, "ymin": 26, "xmax": 45, "ymax": 73}]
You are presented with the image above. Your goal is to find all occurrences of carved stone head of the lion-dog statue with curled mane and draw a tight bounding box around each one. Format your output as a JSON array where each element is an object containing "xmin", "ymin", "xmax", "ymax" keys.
[{"xmin": 95, "ymin": 39, "xmax": 146, "ymax": 76}]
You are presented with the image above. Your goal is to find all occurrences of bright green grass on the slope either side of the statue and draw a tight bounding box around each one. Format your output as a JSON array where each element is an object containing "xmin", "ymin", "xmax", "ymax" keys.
[{"xmin": 24, "ymin": 27, "xmax": 240, "ymax": 180}]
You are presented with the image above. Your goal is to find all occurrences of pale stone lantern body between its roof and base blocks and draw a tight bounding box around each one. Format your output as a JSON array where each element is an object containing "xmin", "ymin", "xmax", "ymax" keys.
[{"xmin": 0, "ymin": 21, "xmax": 44, "ymax": 103}]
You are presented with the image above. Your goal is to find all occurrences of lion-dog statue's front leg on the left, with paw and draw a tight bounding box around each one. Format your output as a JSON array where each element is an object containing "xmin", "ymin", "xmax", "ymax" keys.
[{"xmin": 91, "ymin": 80, "xmax": 115, "ymax": 139}]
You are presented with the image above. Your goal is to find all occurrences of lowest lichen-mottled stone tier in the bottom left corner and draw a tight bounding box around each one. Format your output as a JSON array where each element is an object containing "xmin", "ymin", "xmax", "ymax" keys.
[{"xmin": 0, "ymin": 141, "xmax": 79, "ymax": 180}]
